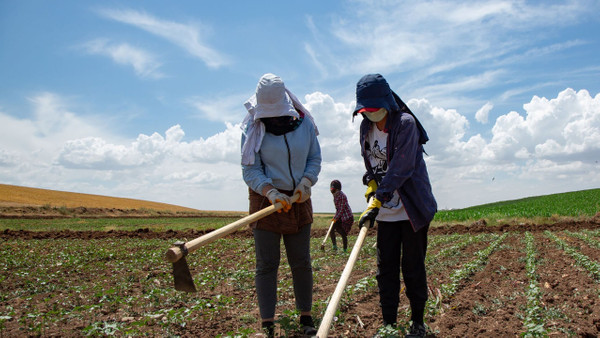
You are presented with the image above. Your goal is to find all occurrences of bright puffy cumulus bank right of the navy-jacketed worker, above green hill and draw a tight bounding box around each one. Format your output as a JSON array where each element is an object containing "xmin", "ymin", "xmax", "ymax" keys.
[{"xmin": 424, "ymin": 89, "xmax": 600, "ymax": 207}]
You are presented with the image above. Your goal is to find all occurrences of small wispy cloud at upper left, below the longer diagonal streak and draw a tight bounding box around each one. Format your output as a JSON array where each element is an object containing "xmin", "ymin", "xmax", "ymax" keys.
[{"xmin": 83, "ymin": 39, "xmax": 164, "ymax": 79}]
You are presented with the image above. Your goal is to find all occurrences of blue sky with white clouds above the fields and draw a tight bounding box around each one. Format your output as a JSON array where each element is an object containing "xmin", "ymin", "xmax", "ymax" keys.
[{"xmin": 0, "ymin": 0, "xmax": 600, "ymax": 212}]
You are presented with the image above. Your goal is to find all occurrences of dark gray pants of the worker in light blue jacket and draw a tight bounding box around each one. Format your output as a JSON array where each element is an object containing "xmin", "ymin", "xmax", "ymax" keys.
[{"xmin": 253, "ymin": 224, "xmax": 313, "ymax": 319}]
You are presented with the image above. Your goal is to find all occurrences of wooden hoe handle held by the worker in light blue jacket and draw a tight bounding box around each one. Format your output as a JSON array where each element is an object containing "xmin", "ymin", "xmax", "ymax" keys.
[{"xmin": 166, "ymin": 194, "xmax": 300, "ymax": 263}]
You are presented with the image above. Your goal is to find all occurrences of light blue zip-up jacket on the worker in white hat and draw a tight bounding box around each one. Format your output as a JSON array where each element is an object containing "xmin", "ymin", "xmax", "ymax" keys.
[{"xmin": 242, "ymin": 119, "xmax": 321, "ymax": 195}]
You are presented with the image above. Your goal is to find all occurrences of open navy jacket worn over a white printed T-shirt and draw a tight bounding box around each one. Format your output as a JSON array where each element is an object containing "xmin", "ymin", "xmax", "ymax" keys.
[{"xmin": 360, "ymin": 111, "xmax": 437, "ymax": 232}]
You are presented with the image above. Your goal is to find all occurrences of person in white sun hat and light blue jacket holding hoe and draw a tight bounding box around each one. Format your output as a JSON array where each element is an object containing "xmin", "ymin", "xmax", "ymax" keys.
[{"xmin": 242, "ymin": 74, "xmax": 321, "ymax": 336}]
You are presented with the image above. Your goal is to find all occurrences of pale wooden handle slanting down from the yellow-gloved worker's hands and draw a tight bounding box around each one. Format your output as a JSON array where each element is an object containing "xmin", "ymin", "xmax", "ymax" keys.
[{"xmin": 317, "ymin": 226, "xmax": 369, "ymax": 338}]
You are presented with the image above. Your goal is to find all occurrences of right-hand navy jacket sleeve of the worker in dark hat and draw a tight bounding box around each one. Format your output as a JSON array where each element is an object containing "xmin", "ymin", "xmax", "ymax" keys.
[{"xmin": 375, "ymin": 114, "xmax": 421, "ymax": 203}]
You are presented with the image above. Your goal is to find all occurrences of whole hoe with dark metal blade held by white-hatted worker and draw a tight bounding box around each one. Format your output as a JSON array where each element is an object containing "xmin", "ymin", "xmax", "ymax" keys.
[{"xmin": 166, "ymin": 194, "xmax": 300, "ymax": 292}]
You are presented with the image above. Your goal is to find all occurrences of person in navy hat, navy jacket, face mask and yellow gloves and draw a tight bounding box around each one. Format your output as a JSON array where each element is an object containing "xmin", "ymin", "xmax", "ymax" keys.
[{"xmin": 352, "ymin": 74, "xmax": 437, "ymax": 337}]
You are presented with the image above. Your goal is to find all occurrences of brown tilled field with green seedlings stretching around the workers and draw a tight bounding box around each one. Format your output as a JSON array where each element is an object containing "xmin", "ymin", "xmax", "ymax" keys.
[{"xmin": 0, "ymin": 186, "xmax": 600, "ymax": 337}]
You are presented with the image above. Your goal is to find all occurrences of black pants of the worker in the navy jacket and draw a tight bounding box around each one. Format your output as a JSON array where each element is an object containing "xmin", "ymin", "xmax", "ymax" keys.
[{"xmin": 377, "ymin": 221, "xmax": 429, "ymax": 324}]
